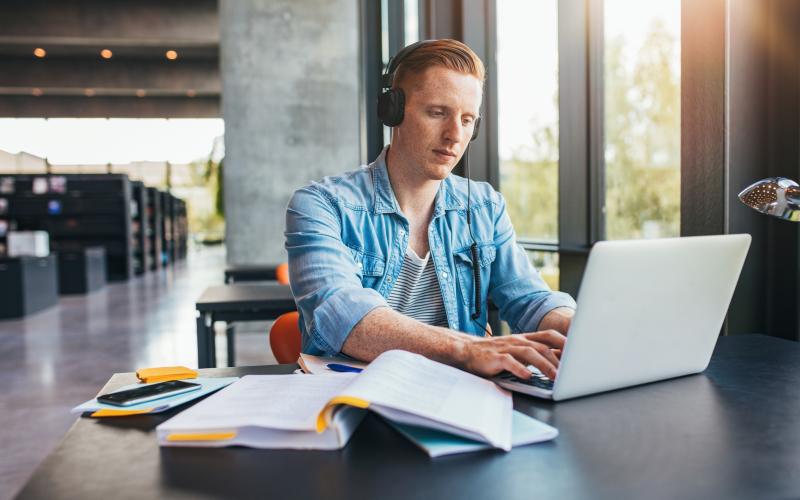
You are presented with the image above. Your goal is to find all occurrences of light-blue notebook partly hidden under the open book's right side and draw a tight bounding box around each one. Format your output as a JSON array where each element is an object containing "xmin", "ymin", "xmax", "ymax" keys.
[{"xmin": 387, "ymin": 410, "xmax": 558, "ymax": 458}]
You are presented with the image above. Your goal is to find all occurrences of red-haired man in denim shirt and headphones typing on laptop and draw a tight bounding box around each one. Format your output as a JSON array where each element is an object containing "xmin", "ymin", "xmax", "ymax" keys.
[{"xmin": 286, "ymin": 40, "xmax": 575, "ymax": 378}]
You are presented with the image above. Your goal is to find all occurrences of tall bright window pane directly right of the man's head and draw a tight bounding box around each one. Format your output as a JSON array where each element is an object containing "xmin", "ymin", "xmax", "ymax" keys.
[{"xmin": 497, "ymin": 0, "xmax": 558, "ymax": 243}]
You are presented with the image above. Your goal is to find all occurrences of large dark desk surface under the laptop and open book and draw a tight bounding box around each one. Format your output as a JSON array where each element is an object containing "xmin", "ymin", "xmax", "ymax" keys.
[{"xmin": 20, "ymin": 335, "xmax": 800, "ymax": 500}]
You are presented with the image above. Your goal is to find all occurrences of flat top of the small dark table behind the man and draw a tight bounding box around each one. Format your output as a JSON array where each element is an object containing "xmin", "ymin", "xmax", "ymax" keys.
[{"xmin": 196, "ymin": 283, "xmax": 295, "ymax": 312}]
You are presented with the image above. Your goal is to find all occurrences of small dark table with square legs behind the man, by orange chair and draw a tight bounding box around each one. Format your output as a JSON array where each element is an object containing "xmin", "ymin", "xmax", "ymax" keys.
[{"xmin": 195, "ymin": 283, "xmax": 296, "ymax": 368}]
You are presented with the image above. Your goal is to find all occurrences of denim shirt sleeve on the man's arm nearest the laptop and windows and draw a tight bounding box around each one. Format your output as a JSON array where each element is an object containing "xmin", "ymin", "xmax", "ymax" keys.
[{"xmin": 489, "ymin": 192, "xmax": 576, "ymax": 333}]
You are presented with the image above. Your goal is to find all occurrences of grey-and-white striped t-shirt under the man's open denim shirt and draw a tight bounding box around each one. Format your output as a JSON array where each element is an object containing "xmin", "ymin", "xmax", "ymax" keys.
[{"xmin": 386, "ymin": 247, "xmax": 447, "ymax": 327}]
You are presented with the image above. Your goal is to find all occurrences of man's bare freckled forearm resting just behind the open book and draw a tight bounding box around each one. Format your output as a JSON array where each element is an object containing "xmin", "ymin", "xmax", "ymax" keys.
[{"xmin": 342, "ymin": 307, "xmax": 473, "ymax": 367}]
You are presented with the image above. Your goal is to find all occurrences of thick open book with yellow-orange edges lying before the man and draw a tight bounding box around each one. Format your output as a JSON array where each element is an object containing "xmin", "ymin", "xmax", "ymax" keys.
[{"xmin": 156, "ymin": 351, "xmax": 512, "ymax": 451}]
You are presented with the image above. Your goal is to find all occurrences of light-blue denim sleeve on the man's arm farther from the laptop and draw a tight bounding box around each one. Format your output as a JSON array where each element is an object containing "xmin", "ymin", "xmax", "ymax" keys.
[{"xmin": 285, "ymin": 184, "xmax": 386, "ymax": 356}]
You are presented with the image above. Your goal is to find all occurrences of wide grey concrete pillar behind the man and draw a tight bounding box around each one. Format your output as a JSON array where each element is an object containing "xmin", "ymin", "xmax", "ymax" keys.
[{"xmin": 220, "ymin": 0, "xmax": 359, "ymax": 265}]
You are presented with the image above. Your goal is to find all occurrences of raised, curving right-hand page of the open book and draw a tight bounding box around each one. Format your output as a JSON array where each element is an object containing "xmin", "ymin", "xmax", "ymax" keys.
[{"xmin": 341, "ymin": 351, "xmax": 512, "ymax": 450}]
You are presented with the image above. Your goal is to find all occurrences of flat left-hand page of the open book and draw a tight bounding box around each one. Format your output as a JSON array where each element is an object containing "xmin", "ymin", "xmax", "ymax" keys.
[{"xmin": 159, "ymin": 373, "xmax": 357, "ymax": 431}]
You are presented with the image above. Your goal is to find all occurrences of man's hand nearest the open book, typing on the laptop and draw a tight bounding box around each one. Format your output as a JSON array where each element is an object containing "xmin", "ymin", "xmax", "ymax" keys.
[{"xmin": 459, "ymin": 330, "xmax": 566, "ymax": 380}]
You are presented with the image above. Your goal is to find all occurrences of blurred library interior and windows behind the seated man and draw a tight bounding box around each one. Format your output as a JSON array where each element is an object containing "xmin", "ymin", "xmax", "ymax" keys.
[{"xmin": 0, "ymin": 0, "xmax": 800, "ymax": 497}]
